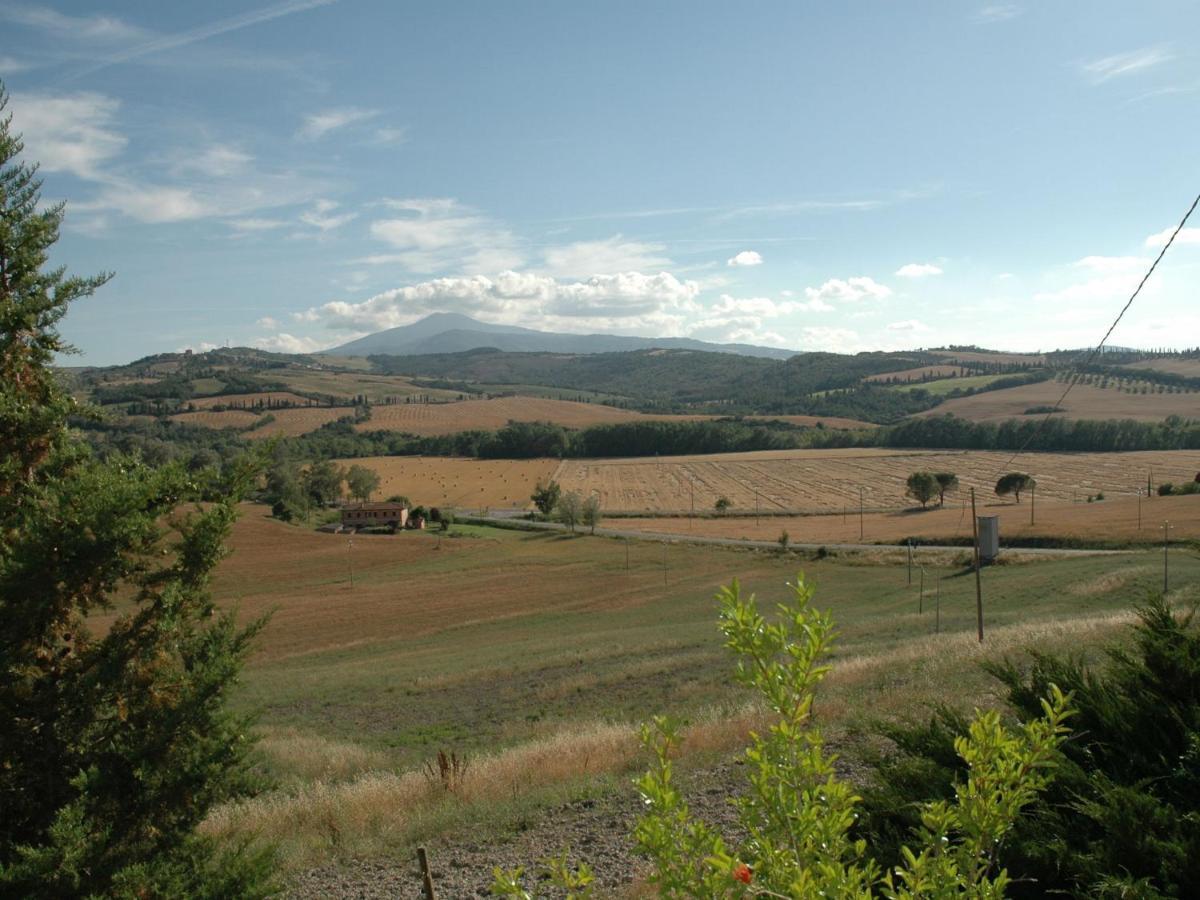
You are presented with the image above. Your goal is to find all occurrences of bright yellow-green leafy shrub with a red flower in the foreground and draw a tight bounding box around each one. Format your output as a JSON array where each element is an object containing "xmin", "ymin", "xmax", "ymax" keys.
[{"xmin": 493, "ymin": 578, "xmax": 1067, "ymax": 898}]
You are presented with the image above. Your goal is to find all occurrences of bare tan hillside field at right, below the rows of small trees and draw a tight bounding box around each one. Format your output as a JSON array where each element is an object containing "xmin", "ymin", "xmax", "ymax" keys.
[{"xmin": 922, "ymin": 382, "xmax": 1200, "ymax": 422}]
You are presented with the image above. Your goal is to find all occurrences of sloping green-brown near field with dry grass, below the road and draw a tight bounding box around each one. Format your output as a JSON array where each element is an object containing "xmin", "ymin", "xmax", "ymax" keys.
[{"xmin": 177, "ymin": 506, "xmax": 1200, "ymax": 895}]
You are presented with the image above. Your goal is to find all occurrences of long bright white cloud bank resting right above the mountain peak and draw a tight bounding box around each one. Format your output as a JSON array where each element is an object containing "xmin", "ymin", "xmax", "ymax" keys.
[{"xmin": 295, "ymin": 271, "xmax": 700, "ymax": 335}]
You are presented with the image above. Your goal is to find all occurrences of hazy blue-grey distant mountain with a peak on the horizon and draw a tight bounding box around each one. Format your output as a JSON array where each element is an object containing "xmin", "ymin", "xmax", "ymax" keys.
[{"xmin": 324, "ymin": 312, "xmax": 796, "ymax": 359}]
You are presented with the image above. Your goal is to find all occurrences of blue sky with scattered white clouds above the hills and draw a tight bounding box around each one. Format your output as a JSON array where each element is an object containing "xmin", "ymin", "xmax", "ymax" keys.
[{"xmin": 7, "ymin": 0, "xmax": 1200, "ymax": 365}]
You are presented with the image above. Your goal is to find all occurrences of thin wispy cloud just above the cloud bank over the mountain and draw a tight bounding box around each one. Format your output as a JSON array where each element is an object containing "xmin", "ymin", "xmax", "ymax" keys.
[{"xmin": 367, "ymin": 197, "xmax": 523, "ymax": 275}]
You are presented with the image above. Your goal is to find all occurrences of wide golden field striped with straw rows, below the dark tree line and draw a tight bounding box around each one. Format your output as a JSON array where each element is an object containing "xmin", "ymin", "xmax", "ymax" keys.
[{"xmin": 554, "ymin": 449, "xmax": 1200, "ymax": 512}]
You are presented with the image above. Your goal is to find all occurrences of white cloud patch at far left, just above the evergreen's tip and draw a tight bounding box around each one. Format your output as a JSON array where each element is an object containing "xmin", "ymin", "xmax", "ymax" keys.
[{"xmin": 11, "ymin": 91, "xmax": 127, "ymax": 180}]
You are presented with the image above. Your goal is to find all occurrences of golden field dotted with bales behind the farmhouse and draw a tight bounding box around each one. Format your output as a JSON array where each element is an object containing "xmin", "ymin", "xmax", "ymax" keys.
[{"xmin": 340, "ymin": 456, "xmax": 558, "ymax": 510}]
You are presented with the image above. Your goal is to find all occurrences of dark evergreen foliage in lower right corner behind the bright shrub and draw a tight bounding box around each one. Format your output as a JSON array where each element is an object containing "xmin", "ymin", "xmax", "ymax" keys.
[{"xmin": 860, "ymin": 598, "xmax": 1200, "ymax": 898}]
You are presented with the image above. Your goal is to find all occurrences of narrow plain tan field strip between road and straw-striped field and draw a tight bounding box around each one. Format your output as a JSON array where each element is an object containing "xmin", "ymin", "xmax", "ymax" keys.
[{"xmin": 605, "ymin": 494, "xmax": 1200, "ymax": 544}]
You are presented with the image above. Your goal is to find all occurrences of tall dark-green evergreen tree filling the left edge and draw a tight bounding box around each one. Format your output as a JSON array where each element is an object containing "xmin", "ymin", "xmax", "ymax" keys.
[{"xmin": 0, "ymin": 86, "xmax": 270, "ymax": 898}]
